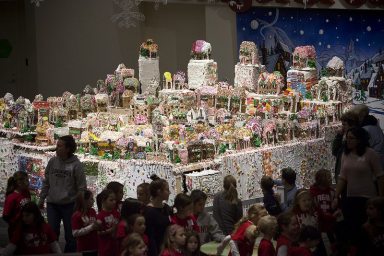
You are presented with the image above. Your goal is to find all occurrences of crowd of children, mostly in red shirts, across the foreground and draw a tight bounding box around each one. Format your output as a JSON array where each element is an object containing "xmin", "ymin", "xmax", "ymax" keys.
[{"xmin": 3, "ymin": 165, "xmax": 384, "ymax": 256}]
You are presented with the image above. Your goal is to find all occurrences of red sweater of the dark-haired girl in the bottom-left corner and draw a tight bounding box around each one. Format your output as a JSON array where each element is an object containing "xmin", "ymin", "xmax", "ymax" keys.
[{"xmin": 10, "ymin": 223, "xmax": 57, "ymax": 255}]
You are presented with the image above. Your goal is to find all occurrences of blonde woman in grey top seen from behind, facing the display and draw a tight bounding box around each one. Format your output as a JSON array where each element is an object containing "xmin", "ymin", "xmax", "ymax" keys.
[{"xmin": 213, "ymin": 175, "xmax": 243, "ymax": 235}]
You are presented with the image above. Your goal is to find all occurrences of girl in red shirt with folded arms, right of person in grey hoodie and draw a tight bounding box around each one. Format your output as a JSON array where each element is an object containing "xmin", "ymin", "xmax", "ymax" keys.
[{"xmin": 72, "ymin": 190, "xmax": 99, "ymax": 252}]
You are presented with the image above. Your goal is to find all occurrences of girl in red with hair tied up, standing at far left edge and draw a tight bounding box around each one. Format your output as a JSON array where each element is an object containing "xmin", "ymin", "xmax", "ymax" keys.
[{"xmin": 3, "ymin": 171, "xmax": 31, "ymax": 238}]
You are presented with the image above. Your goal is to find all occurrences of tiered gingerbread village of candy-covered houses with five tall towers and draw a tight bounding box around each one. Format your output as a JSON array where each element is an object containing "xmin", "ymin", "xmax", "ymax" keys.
[{"xmin": 0, "ymin": 40, "xmax": 352, "ymax": 164}]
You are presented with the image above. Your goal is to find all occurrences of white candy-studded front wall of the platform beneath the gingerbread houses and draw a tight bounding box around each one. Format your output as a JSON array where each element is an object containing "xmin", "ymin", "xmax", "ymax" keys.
[{"xmin": 0, "ymin": 124, "xmax": 340, "ymax": 205}]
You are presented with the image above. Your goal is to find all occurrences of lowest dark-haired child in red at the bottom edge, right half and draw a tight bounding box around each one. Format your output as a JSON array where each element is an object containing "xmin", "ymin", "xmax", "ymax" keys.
[{"xmin": 288, "ymin": 225, "xmax": 321, "ymax": 256}]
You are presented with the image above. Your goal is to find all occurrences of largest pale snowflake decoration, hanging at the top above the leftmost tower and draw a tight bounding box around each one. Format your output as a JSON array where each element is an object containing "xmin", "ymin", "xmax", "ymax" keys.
[{"xmin": 111, "ymin": 0, "xmax": 145, "ymax": 28}]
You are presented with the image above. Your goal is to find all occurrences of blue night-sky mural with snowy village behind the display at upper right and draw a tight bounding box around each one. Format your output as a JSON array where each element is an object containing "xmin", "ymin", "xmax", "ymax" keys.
[{"xmin": 237, "ymin": 8, "xmax": 384, "ymax": 125}]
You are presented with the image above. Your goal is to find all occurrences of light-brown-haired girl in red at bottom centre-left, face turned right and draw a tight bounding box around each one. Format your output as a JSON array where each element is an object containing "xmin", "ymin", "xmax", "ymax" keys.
[{"xmin": 160, "ymin": 224, "xmax": 186, "ymax": 256}]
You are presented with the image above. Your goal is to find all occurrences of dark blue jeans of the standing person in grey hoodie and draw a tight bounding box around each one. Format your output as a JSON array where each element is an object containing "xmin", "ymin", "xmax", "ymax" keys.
[{"xmin": 47, "ymin": 203, "xmax": 76, "ymax": 252}]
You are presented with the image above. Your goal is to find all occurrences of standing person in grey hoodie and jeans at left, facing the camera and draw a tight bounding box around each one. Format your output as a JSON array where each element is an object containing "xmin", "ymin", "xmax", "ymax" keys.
[{"xmin": 39, "ymin": 135, "xmax": 87, "ymax": 252}]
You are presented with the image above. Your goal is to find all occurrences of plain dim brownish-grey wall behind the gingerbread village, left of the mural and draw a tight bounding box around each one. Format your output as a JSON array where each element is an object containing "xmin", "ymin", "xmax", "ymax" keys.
[{"xmin": 35, "ymin": 0, "xmax": 218, "ymax": 96}]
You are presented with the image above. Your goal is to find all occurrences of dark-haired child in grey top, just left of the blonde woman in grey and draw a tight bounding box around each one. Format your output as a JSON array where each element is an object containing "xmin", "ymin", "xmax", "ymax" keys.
[{"xmin": 191, "ymin": 189, "xmax": 225, "ymax": 244}]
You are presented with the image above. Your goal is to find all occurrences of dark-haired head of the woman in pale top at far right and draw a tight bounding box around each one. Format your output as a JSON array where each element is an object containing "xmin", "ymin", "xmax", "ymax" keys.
[{"xmin": 344, "ymin": 127, "xmax": 369, "ymax": 156}]
